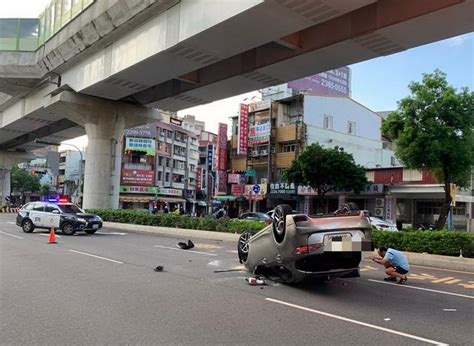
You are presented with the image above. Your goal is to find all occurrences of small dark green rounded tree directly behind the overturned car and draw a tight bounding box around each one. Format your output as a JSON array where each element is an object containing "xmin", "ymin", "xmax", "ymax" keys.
[{"xmin": 283, "ymin": 144, "xmax": 368, "ymax": 211}]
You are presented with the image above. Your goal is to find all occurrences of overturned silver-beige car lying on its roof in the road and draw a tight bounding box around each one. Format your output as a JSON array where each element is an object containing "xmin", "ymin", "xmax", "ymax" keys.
[{"xmin": 237, "ymin": 203, "xmax": 373, "ymax": 283}]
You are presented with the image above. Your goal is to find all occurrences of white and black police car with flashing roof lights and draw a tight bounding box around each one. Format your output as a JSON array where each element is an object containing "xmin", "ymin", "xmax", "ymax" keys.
[{"xmin": 16, "ymin": 202, "xmax": 102, "ymax": 235}]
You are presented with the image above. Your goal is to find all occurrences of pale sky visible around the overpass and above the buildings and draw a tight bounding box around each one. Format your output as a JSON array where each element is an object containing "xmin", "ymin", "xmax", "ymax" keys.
[{"xmin": 0, "ymin": 0, "xmax": 474, "ymax": 151}]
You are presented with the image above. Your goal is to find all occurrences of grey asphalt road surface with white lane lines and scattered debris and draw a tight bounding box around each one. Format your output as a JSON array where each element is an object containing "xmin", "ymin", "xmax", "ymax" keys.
[{"xmin": 0, "ymin": 214, "xmax": 474, "ymax": 345}]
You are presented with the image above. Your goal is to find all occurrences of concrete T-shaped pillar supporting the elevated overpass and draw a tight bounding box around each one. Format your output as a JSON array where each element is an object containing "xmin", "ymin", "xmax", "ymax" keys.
[{"xmin": 45, "ymin": 91, "xmax": 161, "ymax": 209}]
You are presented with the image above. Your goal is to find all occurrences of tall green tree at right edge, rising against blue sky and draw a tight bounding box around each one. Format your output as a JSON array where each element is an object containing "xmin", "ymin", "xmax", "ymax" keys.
[{"xmin": 382, "ymin": 70, "xmax": 474, "ymax": 229}]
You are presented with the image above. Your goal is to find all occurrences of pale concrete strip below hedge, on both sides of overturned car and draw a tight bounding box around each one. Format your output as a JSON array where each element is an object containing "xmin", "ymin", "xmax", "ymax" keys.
[{"xmin": 104, "ymin": 222, "xmax": 474, "ymax": 272}]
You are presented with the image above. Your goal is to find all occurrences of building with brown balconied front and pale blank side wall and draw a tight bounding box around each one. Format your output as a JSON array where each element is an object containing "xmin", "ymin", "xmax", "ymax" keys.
[{"xmin": 230, "ymin": 92, "xmax": 399, "ymax": 211}]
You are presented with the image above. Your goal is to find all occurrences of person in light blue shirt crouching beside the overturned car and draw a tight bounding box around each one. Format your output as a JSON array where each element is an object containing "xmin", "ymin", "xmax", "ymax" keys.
[{"xmin": 369, "ymin": 246, "xmax": 410, "ymax": 284}]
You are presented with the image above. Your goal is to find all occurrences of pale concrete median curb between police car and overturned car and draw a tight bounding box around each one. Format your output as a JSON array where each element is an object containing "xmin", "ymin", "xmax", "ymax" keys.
[{"xmin": 104, "ymin": 222, "xmax": 240, "ymax": 242}]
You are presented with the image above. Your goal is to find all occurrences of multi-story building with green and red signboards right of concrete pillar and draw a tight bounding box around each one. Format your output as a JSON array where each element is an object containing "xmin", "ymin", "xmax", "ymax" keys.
[{"xmin": 120, "ymin": 122, "xmax": 199, "ymax": 212}]
